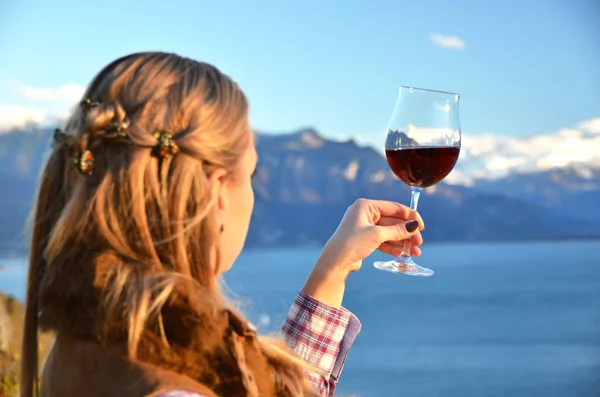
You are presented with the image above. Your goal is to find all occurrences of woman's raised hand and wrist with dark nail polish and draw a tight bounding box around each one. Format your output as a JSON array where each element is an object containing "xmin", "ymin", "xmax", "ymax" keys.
[{"xmin": 303, "ymin": 199, "xmax": 425, "ymax": 307}]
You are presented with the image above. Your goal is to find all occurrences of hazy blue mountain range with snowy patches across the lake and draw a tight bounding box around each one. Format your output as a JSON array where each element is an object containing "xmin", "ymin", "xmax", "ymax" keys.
[{"xmin": 0, "ymin": 125, "xmax": 600, "ymax": 253}]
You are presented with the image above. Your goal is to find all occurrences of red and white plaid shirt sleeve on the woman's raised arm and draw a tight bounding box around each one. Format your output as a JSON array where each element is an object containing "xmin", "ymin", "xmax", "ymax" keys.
[{"xmin": 281, "ymin": 291, "xmax": 362, "ymax": 397}]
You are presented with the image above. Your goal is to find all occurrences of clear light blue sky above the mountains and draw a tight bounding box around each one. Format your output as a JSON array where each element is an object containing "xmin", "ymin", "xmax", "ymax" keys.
[{"xmin": 0, "ymin": 0, "xmax": 600, "ymax": 145}]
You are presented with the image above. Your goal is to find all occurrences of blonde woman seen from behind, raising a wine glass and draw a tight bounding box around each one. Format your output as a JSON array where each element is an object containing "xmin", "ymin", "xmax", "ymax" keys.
[{"xmin": 21, "ymin": 53, "xmax": 423, "ymax": 397}]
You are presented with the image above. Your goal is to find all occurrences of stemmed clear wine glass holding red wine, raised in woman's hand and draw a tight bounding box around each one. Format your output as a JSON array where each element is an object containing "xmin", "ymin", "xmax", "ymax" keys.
[{"xmin": 374, "ymin": 86, "xmax": 461, "ymax": 276}]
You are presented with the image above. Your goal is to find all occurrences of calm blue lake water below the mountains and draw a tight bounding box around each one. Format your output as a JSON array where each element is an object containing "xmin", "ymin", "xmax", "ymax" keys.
[{"xmin": 0, "ymin": 241, "xmax": 600, "ymax": 397}]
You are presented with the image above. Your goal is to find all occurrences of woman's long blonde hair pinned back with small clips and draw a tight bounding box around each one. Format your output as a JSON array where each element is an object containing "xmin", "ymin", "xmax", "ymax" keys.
[{"xmin": 21, "ymin": 52, "xmax": 313, "ymax": 397}]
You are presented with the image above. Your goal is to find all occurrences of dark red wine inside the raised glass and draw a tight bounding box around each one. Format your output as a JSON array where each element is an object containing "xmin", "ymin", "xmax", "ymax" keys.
[{"xmin": 385, "ymin": 146, "xmax": 460, "ymax": 187}]
